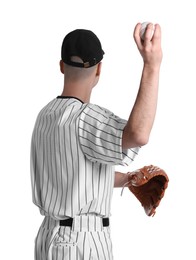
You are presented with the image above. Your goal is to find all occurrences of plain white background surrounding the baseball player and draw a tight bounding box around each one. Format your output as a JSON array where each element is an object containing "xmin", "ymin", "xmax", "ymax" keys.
[{"xmin": 0, "ymin": 0, "xmax": 196, "ymax": 260}]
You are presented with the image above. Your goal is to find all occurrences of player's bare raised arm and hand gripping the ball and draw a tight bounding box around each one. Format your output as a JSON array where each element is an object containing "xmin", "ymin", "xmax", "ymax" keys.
[{"xmin": 122, "ymin": 23, "xmax": 162, "ymax": 149}]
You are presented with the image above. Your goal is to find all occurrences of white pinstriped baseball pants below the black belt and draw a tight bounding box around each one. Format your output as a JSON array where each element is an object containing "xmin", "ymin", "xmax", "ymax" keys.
[{"xmin": 35, "ymin": 215, "xmax": 113, "ymax": 260}]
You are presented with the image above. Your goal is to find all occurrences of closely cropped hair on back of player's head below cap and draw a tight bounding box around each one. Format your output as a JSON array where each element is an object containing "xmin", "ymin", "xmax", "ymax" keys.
[{"xmin": 64, "ymin": 56, "xmax": 97, "ymax": 81}]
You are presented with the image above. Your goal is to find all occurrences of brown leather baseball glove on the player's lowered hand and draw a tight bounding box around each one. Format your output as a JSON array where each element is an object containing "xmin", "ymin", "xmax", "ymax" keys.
[{"xmin": 128, "ymin": 165, "xmax": 169, "ymax": 217}]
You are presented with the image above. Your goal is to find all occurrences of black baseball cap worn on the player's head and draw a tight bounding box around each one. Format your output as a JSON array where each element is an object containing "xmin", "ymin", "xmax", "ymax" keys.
[{"xmin": 61, "ymin": 29, "xmax": 104, "ymax": 68}]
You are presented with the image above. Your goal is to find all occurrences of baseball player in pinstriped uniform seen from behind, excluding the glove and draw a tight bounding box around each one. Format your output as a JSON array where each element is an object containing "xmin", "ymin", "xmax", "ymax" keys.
[{"xmin": 31, "ymin": 23, "xmax": 162, "ymax": 260}]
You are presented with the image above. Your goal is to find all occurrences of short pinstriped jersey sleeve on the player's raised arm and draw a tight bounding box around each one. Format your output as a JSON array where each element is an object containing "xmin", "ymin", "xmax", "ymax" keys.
[{"xmin": 79, "ymin": 104, "xmax": 140, "ymax": 166}]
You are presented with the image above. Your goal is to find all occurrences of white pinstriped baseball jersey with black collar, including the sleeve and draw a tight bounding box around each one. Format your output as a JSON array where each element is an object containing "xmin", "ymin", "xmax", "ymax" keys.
[{"xmin": 31, "ymin": 97, "xmax": 139, "ymax": 219}]
